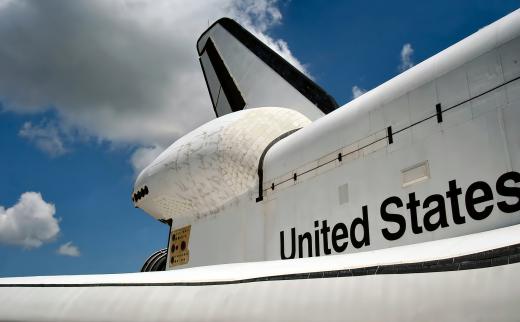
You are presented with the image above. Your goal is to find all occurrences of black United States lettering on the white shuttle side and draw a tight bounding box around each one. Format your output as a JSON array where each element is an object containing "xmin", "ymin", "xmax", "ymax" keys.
[{"xmin": 280, "ymin": 171, "xmax": 520, "ymax": 259}]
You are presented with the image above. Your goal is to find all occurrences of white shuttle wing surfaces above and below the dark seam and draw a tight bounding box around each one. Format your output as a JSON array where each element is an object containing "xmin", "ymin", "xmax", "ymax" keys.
[{"xmin": 0, "ymin": 225, "xmax": 520, "ymax": 321}]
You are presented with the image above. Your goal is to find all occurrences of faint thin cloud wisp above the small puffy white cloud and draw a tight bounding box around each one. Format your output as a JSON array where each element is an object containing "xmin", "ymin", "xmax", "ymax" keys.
[{"xmin": 18, "ymin": 122, "xmax": 67, "ymax": 157}]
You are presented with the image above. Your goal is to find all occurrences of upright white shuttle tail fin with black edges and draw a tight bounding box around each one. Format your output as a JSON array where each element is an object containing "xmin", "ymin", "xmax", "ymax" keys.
[{"xmin": 197, "ymin": 18, "xmax": 338, "ymax": 120}]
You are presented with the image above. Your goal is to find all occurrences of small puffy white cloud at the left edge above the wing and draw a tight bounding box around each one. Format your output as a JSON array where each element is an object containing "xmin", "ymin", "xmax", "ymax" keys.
[{"xmin": 0, "ymin": 192, "xmax": 60, "ymax": 248}]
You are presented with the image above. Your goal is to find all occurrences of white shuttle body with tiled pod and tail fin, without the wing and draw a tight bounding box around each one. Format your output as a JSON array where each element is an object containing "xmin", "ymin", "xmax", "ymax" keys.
[{"xmin": 134, "ymin": 12, "xmax": 520, "ymax": 269}]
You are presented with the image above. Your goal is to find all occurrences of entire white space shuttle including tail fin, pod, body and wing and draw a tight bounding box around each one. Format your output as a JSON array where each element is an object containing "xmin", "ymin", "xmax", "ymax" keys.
[{"xmin": 0, "ymin": 10, "xmax": 520, "ymax": 321}]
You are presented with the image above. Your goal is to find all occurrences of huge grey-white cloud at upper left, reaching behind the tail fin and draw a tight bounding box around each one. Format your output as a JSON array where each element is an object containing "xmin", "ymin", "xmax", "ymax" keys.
[{"xmin": 0, "ymin": 0, "xmax": 304, "ymax": 161}]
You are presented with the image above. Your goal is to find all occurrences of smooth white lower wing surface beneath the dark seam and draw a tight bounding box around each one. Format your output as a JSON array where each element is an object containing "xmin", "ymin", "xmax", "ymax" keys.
[{"xmin": 0, "ymin": 264, "xmax": 520, "ymax": 322}]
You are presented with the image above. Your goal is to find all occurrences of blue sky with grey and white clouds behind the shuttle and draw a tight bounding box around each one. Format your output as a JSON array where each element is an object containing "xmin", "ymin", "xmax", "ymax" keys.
[{"xmin": 0, "ymin": 0, "xmax": 518, "ymax": 276}]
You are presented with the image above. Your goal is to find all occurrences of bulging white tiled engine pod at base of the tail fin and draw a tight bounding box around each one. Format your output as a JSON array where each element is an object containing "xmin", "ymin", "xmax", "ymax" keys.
[{"xmin": 132, "ymin": 107, "xmax": 310, "ymax": 220}]
